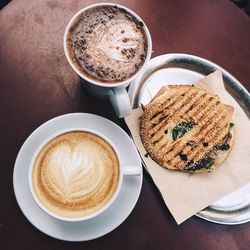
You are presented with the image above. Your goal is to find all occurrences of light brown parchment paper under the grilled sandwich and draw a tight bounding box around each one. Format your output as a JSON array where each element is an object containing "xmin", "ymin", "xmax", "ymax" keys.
[{"xmin": 125, "ymin": 70, "xmax": 250, "ymax": 224}]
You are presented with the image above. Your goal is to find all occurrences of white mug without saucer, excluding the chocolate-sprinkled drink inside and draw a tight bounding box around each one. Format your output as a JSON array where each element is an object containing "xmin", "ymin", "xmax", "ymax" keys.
[{"xmin": 63, "ymin": 3, "xmax": 152, "ymax": 118}]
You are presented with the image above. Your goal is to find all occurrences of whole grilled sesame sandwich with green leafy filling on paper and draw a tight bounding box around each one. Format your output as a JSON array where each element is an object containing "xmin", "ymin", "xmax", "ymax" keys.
[{"xmin": 140, "ymin": 85, "xmax": 234, "ymax": 172}]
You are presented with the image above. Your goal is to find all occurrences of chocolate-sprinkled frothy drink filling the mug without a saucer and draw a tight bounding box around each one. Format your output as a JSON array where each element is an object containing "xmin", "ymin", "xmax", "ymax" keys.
[{"xmin": 66, "ymin": 5, "xmax": 148, "ymax": 84}]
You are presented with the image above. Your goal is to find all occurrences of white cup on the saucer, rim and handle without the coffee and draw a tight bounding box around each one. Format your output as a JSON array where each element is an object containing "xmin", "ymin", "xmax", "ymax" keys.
[{"xmin": 28, "ymin": 128, "xmax": 142, "ymax": 222}]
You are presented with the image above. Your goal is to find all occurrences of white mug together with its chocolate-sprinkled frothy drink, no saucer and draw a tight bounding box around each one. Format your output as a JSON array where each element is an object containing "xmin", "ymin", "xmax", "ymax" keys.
[{"xmin": 63, "ymin": 3, "xmax": 152, "ymax": 118}]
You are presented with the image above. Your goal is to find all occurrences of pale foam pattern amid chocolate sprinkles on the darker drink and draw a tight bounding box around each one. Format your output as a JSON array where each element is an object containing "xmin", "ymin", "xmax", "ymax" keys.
[{"xmin": 86, "ymin": 20, "xmax": 143, "ymax": 65}]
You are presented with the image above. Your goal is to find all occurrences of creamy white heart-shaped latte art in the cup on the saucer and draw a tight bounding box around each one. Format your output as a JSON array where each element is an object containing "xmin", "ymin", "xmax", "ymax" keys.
[{"xmin": 47, "ymin": 145, "xmax": 105, "ymax": 202}]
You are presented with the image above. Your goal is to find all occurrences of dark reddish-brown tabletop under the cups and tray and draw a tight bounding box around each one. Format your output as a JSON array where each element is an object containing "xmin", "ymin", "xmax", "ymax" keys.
[{"xmin": 0, "ymin": 0, "xmax": 250, "ymax": 250}]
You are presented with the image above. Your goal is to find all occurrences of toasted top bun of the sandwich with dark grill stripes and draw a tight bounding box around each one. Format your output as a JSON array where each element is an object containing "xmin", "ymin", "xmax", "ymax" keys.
[{"xmin": 141, "ymin": 86, "xmax": 233, "ymax": 172}]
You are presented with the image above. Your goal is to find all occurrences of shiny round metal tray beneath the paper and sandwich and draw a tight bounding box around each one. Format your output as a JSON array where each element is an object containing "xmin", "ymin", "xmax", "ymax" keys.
[{"xmin": 129, "ymin": 53, "xmax": 250, "ymax": 225}]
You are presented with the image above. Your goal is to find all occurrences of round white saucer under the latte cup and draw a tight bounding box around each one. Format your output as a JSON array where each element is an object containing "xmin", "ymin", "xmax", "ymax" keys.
[{"xmin": 13, "ymin": 113, "xmax": 143, "ymax": 241}]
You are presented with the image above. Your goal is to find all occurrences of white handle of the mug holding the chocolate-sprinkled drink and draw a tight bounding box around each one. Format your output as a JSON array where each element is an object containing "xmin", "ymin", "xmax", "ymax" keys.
[{"xmin": 109, "ymin": 87, "xmax": 131, "ymax": 118}]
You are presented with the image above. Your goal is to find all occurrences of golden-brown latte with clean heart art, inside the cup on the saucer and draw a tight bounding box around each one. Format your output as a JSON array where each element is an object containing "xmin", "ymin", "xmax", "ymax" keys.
[{"xmin": 32, "ymin": 131, "xmax": 120, "ymax": 218}]
